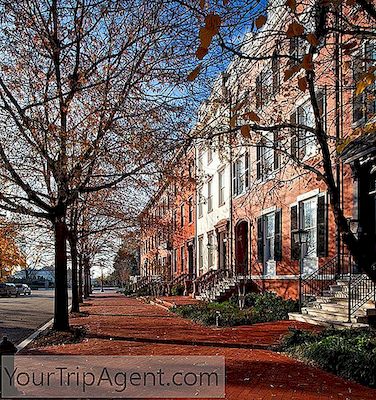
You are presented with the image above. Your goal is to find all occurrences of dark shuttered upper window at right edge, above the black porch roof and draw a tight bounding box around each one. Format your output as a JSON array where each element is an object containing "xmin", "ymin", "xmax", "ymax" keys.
[{"xmin": 353, "ymin": 42, "xmax": 376, "ymax": 122}]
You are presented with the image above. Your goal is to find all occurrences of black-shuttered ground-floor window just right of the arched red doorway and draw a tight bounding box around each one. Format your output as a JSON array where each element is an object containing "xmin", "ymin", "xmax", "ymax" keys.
[{"xmin": 257, "ymin": 210, "xmax": 282, "ymax": 263}]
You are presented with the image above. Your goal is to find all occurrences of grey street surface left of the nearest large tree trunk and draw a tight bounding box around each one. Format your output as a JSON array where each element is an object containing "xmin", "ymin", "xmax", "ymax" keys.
[{"xmin": 0, "ymin": 290, "xmax": 71, "ymax": 344}]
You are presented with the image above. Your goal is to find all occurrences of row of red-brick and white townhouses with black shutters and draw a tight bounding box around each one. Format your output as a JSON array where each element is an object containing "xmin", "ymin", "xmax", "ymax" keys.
[{"xmin": 140, "ymin": 0, "xmax": 376, "ymax": 312}]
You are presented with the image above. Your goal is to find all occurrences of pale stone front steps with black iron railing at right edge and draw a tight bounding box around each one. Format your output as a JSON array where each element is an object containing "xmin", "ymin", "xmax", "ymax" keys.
[{"xmin": 289, "ymin": 279, "xmax": 376, "ymax": 328}]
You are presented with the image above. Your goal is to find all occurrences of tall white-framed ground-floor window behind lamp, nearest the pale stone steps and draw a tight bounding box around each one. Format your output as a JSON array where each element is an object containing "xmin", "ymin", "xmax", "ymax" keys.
[{"xmin": 300, "ymin": 197, "xmax": 318, "ymax": 275}]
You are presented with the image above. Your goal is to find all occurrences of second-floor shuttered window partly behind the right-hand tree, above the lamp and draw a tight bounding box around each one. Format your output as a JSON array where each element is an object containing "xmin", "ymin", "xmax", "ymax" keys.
[{"xmin": 290, "ymin": 91, "xmax": 326, "ymax": 160}]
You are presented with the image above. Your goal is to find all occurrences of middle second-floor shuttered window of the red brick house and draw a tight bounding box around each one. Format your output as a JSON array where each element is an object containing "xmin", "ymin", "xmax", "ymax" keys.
[{"xmin": 256, "ymin": 132, "xmax": 280, "ymax": 181}]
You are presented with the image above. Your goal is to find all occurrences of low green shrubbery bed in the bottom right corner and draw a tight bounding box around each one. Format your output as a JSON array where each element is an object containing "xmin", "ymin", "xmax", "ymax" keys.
[{"xmin": 281, "ymin": 329, "xmax": 376, "ymax": 387}]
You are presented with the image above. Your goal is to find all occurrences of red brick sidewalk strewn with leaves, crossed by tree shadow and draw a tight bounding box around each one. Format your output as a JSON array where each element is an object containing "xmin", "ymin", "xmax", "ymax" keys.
[{"xmin": 25, "ymin": 294, "xmax": 376, "ymax": 400}]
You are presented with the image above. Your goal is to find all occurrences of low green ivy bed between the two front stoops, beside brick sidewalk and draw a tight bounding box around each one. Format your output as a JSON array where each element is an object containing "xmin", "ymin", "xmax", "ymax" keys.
[{"xmin": 175, "ymin": 292, "xmax": 297, "ymax": 326}]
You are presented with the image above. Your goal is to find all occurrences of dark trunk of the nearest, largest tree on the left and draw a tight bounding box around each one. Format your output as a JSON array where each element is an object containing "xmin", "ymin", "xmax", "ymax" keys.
[{"xmin": 53, "ymin": 217, "xmax": 69, "ymax": 331}]
